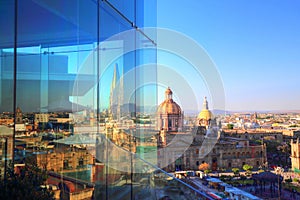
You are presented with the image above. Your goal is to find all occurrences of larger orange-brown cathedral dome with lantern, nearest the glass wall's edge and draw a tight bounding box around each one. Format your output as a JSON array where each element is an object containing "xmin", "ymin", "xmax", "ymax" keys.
[{"xmin": 157, "ymin": 87, "xmax": 181, "ymax": 115}]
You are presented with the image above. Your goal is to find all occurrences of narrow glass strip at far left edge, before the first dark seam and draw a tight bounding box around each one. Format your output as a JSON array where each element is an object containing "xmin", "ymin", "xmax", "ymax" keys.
[{"xmin": 0, "ymin": 0, "xmax": 15, "ymax": 178}]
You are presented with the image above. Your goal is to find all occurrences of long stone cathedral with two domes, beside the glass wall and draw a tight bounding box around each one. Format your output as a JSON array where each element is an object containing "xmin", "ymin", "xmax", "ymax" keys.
[{"xmin": 156, "ymin": 88, "xmax": 267, "ymax": 172}]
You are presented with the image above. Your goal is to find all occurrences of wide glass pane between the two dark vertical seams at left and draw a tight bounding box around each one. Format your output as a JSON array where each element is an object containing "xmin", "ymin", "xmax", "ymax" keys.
[{"xmin": 15, "ymin": 0, "xmax": 99, "ymax": 198}]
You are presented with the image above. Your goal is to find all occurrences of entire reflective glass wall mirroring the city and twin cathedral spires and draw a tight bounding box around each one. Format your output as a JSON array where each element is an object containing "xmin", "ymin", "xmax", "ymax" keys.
[{"xmin": 0, "ymin": 0, "xmax": 171, "ymax": 199}]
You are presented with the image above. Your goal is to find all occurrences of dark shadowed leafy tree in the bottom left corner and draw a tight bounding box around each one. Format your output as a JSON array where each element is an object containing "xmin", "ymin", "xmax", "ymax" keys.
[{"xmin": 0, "ymin": 160, "xmax": 54, "ymax": 200}]
